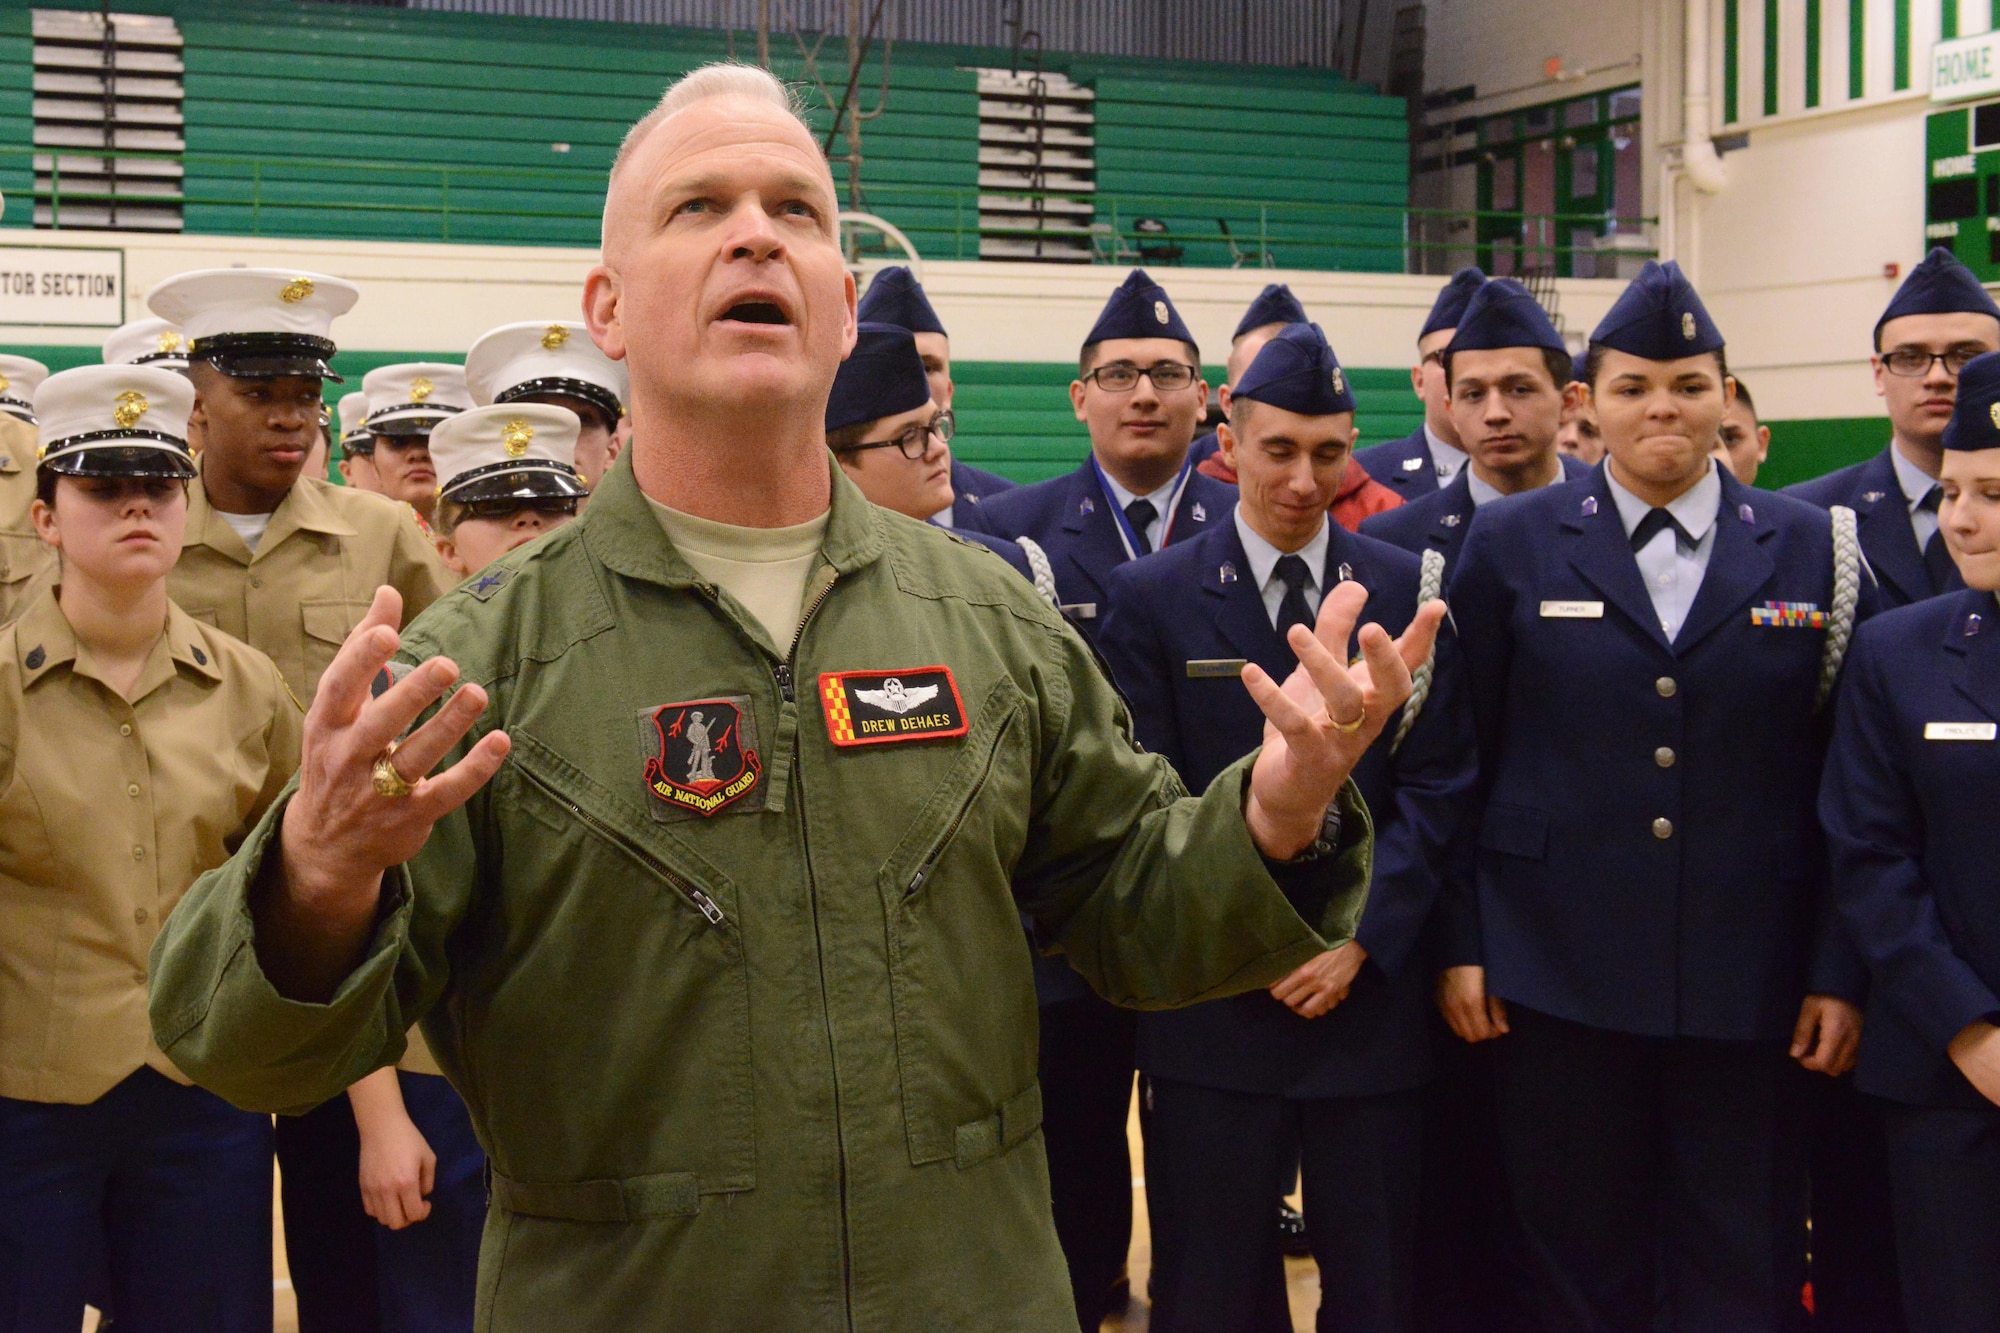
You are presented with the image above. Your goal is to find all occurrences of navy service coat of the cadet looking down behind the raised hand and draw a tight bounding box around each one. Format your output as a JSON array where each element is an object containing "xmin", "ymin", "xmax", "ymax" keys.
[{"xmin": 1098, "ymin": 522, "xmax": 1474, "ymax": 1097}]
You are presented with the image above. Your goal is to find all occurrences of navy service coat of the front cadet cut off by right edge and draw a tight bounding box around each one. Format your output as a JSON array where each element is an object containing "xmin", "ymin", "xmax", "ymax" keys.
[{"xmin": 1820, "ymin": 590, "xmax": 2000, "ymax": 1109}]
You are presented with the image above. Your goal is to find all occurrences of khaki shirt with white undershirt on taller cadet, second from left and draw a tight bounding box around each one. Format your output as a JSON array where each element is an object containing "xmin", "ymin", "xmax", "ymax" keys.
[{"xmin": 166, "ymin": 464, "xmax": 456, "ymax": 705}]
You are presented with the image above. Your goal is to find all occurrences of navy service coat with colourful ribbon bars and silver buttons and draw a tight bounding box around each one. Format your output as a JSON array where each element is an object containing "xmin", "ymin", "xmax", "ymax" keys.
[{"xmin": 1446, "ymin": 468, "xmax": 1874, "ymax": 1041}]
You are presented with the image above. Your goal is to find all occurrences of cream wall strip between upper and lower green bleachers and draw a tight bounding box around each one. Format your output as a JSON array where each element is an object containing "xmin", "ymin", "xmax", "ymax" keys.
[{"xmin": 0, "ymin": 232, "xmax": 1618, "ymax": 366}]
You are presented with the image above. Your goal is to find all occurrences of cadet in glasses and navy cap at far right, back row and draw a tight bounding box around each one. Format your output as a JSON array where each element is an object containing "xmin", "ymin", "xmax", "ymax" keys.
[{"xmin": 1786, "ymin": 246, "xmax": 2000, "ymax": 606}]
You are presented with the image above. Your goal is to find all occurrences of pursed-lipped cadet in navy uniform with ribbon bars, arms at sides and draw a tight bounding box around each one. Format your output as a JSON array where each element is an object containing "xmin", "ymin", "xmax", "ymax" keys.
[{"xmin": 1440, "ymin": 264, "xmax": 1874, "ymax": 1333}]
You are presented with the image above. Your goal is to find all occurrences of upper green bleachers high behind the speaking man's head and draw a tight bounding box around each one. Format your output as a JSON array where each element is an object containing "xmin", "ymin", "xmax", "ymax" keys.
[{"xmin": 0, "ymin": 0, "xmax": 1406, "ymax": 270}]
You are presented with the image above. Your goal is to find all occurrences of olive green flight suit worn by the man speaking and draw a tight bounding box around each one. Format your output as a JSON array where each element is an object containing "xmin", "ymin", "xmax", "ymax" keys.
[{"xmin": 152, "ymin": 452, "xmax": 1372, "ymax": 1333}]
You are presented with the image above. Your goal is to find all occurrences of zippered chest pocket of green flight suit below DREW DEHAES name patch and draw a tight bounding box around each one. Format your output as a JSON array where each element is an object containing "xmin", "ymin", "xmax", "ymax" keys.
[{"xmin": 878, "ymin": 679, "xmax": 1036, "ymax": 1167}]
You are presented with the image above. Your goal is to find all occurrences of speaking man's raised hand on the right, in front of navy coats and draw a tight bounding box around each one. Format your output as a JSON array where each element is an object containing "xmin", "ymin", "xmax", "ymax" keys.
[{"xmin": 1244, "ymin": 582, "xmax": 1444, "ymax": 861}]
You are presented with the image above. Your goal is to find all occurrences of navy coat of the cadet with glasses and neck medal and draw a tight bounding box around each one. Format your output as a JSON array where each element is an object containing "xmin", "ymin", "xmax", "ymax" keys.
[{"xmin": 980, "ymin": 458, "xmax": 1236, "ymax": 640}]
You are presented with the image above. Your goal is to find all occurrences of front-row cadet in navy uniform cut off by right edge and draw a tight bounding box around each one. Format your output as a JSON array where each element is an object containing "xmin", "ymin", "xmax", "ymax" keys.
[{"xmin": 1820, "ymin": 354, "xmax": 2000, "ymax": 1333}]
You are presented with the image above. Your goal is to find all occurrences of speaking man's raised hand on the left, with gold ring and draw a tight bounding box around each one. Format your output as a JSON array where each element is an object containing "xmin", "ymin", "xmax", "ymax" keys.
[{"xmin": 252, "ymin": 588, "xmax": 508, "ymax": 999}]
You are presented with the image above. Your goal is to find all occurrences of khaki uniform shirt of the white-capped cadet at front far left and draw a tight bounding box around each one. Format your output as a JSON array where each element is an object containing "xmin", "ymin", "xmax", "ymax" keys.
[{"xmin": 0, "ymin": 588, "xmax": 300, "ymax": 1103}]
